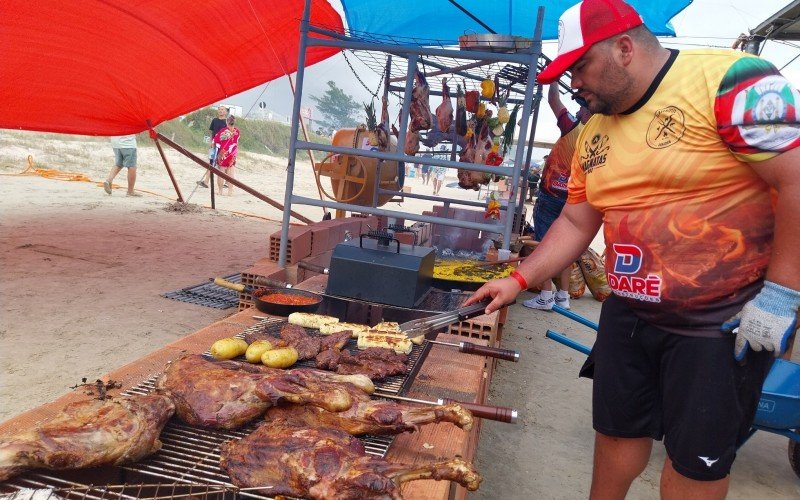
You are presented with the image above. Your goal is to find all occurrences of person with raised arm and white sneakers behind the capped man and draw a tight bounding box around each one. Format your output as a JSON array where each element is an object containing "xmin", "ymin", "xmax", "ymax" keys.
[{"xmin": 522, "ymin": 85, "xmax": 592, "ymax": 311}]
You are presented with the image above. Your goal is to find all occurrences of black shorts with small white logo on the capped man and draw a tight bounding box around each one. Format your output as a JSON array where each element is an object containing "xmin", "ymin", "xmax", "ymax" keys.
[{"xmin": 581, "ymin": 296, "xmax": 773, "ymax": 481}]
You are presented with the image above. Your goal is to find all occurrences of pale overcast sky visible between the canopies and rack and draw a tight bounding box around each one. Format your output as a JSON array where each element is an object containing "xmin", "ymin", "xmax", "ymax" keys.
[{"xmin": 221, "ymin": 0, "xmax": 800, "ymax": 158}]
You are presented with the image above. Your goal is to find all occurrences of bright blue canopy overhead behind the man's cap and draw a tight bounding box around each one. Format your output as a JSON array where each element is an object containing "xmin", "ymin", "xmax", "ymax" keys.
[{"xmin": 341, "ymin": 0, "xmax": 692, "ymax": 44}]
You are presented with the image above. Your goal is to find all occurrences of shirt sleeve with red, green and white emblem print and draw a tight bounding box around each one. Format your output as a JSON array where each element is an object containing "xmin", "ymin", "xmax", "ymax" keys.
[{"xmin": 714, "ymin": 57, "xmax": 800, "ymax": 162}]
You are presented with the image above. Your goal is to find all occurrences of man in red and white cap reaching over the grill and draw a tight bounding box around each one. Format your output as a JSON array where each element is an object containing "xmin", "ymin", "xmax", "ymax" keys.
[{"xmin": 468, "ymin": 0, "xmax": 800, "ymax": 500}]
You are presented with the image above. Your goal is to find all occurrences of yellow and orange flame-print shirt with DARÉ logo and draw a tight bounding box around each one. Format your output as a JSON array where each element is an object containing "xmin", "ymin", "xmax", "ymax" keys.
[{"xmin": 568, "ymin": 50, "xmax": 800, "ymax": 336}]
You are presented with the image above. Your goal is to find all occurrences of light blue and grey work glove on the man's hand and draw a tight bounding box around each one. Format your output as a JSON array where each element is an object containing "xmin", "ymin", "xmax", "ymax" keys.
[{"xmin": 722, "ymin": 281, "xmax": 800, "ymax": 361}]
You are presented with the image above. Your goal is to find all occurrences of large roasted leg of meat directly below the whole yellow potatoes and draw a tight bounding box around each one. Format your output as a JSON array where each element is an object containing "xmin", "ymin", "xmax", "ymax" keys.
[{"xmin": 156, "ymin": 355, "xmax": 375, "ymax": 429}]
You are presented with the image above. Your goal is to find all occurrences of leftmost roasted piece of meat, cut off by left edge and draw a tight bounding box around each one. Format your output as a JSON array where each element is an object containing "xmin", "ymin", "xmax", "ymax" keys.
[{"xmin": 0, "ymin": 395, "xmax": 175, "ymax": 481}]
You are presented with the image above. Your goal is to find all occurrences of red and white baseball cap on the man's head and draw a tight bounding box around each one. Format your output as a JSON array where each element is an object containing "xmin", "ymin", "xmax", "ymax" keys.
[{"xmin": 536, "ymin": 0, "xmax": 644, "ymax": 83}]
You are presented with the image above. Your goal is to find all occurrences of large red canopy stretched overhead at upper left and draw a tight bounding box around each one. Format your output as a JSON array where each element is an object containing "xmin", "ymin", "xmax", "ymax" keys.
[{"xmin": 0, "ymin": 0, "xmax": 343, "ymax": 135}]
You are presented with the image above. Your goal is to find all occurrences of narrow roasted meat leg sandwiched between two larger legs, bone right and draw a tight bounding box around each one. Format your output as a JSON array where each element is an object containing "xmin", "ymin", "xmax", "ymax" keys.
[{"xmin": 266, "ymin": 382, "xmax": 472, "ymax": 436}]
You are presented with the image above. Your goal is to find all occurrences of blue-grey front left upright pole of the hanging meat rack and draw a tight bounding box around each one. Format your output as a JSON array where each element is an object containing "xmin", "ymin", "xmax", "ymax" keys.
[{"xmin": 278, "ymin": 0, "xmax": 311, "ymax": 267}]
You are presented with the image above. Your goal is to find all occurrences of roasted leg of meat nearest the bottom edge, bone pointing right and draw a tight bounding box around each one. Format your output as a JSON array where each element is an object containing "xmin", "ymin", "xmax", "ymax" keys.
[{"xmin": 220, "ymin": 423, "xmax": 481, "ymax": 500}]
